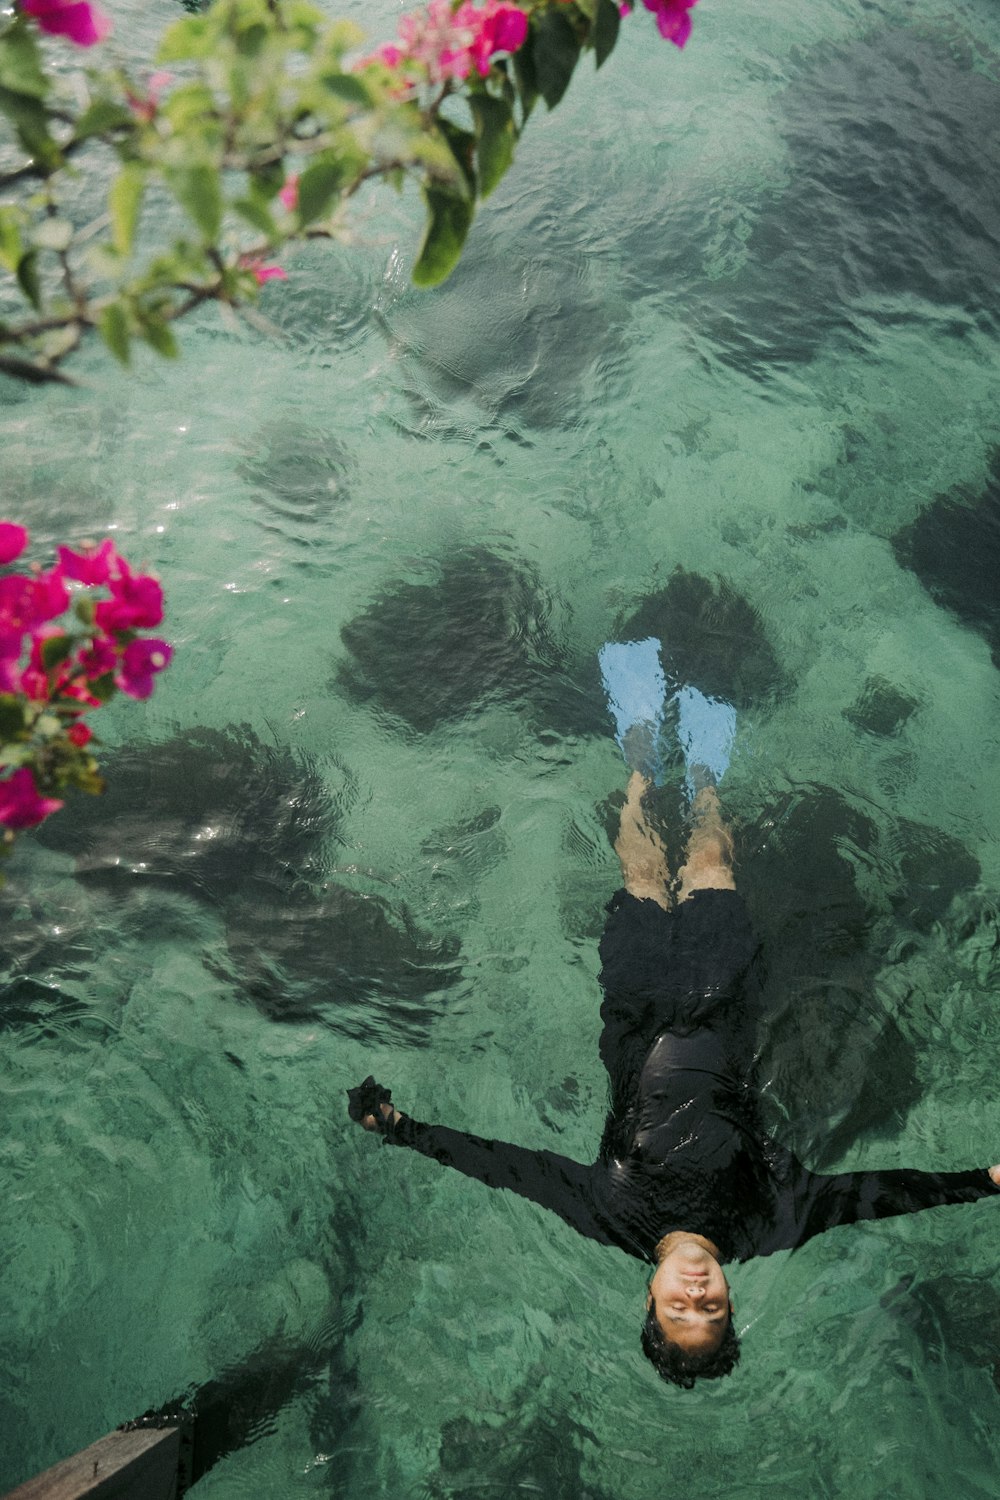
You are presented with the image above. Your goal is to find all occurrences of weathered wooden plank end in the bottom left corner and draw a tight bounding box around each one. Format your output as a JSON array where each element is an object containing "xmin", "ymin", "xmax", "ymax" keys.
[{"xmin": 3, "ymin": 1427, "xmax": 181, "ymax": 1500}]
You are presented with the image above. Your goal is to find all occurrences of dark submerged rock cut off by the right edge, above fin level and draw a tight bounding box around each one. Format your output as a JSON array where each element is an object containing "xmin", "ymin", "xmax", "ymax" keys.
[{"xmin": 892, "ymin": 449, "xmax": 1000, "ymax": 668}]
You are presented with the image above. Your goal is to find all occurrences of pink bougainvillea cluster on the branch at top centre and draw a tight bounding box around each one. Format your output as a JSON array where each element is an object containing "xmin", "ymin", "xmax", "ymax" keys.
[{"xmin": 369, "ymin": 0, "xmax": 528, "ymax": 84}]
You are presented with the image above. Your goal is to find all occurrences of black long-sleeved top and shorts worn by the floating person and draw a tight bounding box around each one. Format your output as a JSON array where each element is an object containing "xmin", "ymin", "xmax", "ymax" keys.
[{"xmin": 377, "ymin": 891, "xmax": 1000, "ymax": 1262}]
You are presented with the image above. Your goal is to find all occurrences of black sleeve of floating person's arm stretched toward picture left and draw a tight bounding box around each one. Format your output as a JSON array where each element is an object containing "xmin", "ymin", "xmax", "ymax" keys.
[{"xmin": 385, "ymin": 1115, "xmax": 609, "ymax": 1244}]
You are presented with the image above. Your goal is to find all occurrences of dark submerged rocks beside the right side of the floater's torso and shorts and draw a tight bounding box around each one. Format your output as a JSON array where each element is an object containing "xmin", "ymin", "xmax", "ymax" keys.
[{"xmin": 738, "ymin": 786, "xmax": 981, "ymax": 1169}]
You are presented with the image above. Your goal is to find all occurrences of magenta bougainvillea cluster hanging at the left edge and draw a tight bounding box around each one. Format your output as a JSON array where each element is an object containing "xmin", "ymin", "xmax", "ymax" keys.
[{"xmin": 0, "ymin": 521, "xmax": 172, "ymax": 830}]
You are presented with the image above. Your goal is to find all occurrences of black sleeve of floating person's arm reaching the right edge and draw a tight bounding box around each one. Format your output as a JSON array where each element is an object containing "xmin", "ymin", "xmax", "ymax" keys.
[{"xmin": 789, "ymin": 1158, "xmax": 1000, "ymax": 1248}]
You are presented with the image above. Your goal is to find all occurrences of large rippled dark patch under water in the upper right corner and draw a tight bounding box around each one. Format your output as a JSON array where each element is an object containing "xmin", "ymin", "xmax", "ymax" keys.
[{"xmin": 627, "ymin": 30, "xmax": 1000, "ymax": 380}]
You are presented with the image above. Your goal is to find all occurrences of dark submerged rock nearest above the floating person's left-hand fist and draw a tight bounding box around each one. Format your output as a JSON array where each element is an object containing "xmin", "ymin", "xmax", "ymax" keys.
[{"xmin": 226, "ymin": 885, "xmax": 460, "ymax": 1046}]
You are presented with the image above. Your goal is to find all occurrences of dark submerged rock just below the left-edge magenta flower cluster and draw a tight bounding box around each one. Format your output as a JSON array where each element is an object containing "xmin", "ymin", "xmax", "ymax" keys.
[{"xmin": 37, "ymin": 725, "xmax": 336, "ymax": 903}]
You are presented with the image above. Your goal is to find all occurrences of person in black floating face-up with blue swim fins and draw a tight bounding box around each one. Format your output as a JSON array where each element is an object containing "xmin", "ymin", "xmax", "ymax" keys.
[{"xmin": 348, "ymin": 639, "xmax": 1000, "ymax": 1389}]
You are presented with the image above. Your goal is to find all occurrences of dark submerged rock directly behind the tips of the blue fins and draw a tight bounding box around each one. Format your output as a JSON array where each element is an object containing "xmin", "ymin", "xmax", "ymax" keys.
[{"xmin": 615, "ymin": 567, "xmax": 784, "ymax": 708}]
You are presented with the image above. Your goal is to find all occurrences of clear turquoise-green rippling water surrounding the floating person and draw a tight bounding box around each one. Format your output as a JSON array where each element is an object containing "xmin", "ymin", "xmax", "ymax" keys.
[{"xmin": 0, "ymin": 0, "xmax": 1000, "ymax": 1500}]
